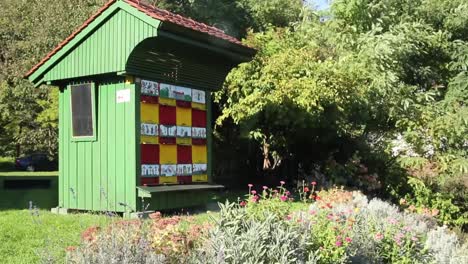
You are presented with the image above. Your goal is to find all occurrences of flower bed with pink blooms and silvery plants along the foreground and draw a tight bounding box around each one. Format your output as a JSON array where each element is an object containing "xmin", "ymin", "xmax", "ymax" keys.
[{"xmin": 64, "ymin": 182, "xmax": 468, "ymax": 263}]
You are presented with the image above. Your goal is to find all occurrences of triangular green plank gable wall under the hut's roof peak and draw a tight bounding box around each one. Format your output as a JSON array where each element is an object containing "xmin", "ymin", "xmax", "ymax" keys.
[{"xmin": 32, "ymin": 6, "xmax": 159, "ymax": 81}]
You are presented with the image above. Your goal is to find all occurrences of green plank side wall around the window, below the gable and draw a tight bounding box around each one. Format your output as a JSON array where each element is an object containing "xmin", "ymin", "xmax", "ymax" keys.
[{"xmin": 59, "ymin": 78, "xmax": 139, "ymax": 212}]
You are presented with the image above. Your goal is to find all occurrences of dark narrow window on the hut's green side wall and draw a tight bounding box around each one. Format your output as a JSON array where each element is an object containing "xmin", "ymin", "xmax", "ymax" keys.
[{"xmin": 71, "ymin": 83, "xmax": 94, "ymax": 137}]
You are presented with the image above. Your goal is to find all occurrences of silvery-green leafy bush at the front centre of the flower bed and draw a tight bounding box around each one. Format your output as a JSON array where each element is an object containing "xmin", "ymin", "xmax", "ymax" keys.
[{"xmin": 190, "ymin": 201, "xmax": 316, "ymax": 263}]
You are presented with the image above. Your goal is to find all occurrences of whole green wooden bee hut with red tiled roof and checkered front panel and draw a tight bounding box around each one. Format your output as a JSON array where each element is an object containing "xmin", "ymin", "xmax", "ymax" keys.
[{"xmin": 26, "ymin": 0, "xmax": 255, "ymax": 212}]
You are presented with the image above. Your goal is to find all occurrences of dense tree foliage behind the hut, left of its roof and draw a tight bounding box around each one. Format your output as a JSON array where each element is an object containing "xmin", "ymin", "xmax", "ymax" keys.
[{"xmin": 0, "ymin": 0, "xmax": 105, "ymax": 157}]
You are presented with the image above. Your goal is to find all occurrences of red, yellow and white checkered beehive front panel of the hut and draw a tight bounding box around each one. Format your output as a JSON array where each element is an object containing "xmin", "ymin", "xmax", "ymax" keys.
[{"xmin": 140, "ymin": 80, "xmax": 208, "ymax": 186}]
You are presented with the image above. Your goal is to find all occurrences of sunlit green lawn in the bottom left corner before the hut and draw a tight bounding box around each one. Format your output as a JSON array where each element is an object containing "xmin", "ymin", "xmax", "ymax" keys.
[{"xmin": 0, "ymin": 210, "xmax": 111, "ymax": 264}]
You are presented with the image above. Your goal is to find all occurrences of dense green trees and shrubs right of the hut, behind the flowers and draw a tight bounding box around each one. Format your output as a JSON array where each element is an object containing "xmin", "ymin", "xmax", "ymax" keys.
[{"xmin": 217, "ymin": 0, "xmax": 468, "ymax": 226}]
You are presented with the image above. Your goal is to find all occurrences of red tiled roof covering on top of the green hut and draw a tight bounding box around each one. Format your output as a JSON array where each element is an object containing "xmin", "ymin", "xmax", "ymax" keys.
[{"xmin": 26, "ymin": 0, "xmax": 249, "ymax": 77}]
